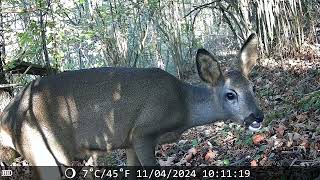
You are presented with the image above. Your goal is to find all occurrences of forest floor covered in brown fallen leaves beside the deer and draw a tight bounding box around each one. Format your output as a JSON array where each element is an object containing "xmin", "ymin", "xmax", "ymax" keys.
[{"xmin": 7, "ymin": 47, "xmax": 320, "ymax": 169}]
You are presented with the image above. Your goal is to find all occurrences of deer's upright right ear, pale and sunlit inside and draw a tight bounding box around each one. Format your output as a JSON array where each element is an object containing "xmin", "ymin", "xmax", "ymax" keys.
[{"xmin": 239, "ymin": 33, "xmax": 258, "ymax": 77}]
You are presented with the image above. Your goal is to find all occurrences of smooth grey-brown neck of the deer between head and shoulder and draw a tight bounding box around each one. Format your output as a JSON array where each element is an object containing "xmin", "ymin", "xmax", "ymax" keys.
[{"xmin": 186, "ymin": 85, "xmax": 227, "ymax": 128}]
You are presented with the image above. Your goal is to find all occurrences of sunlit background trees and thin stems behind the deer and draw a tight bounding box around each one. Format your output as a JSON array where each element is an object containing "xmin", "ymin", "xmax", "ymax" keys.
[{"xmin": 0, "ymin": 0, "xmax": 320, "ymax": 83}]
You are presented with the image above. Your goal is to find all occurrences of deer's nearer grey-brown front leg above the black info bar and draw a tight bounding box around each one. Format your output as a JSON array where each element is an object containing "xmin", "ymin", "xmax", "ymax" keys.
[{"xmin": 133, "ymin": 137, "xmax": 156, "ymax": 166}]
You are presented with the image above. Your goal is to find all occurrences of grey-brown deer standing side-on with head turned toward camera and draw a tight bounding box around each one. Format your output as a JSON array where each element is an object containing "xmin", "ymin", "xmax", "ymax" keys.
[{"xmin": 0, "ymin": 34, "xmax": 264, "ymax": 179}]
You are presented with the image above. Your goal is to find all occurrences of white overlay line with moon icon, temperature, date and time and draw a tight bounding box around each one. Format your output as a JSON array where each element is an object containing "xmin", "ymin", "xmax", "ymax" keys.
[{"xmin": 65, "ymin": 168, "xmax": 250, "ymax": 179}]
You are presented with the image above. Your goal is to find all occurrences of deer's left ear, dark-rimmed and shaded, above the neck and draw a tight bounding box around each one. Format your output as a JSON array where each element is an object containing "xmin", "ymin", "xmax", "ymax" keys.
[{"xmin": 196, "ymin": 49, "xmax": 222, "ymax": 85}]
